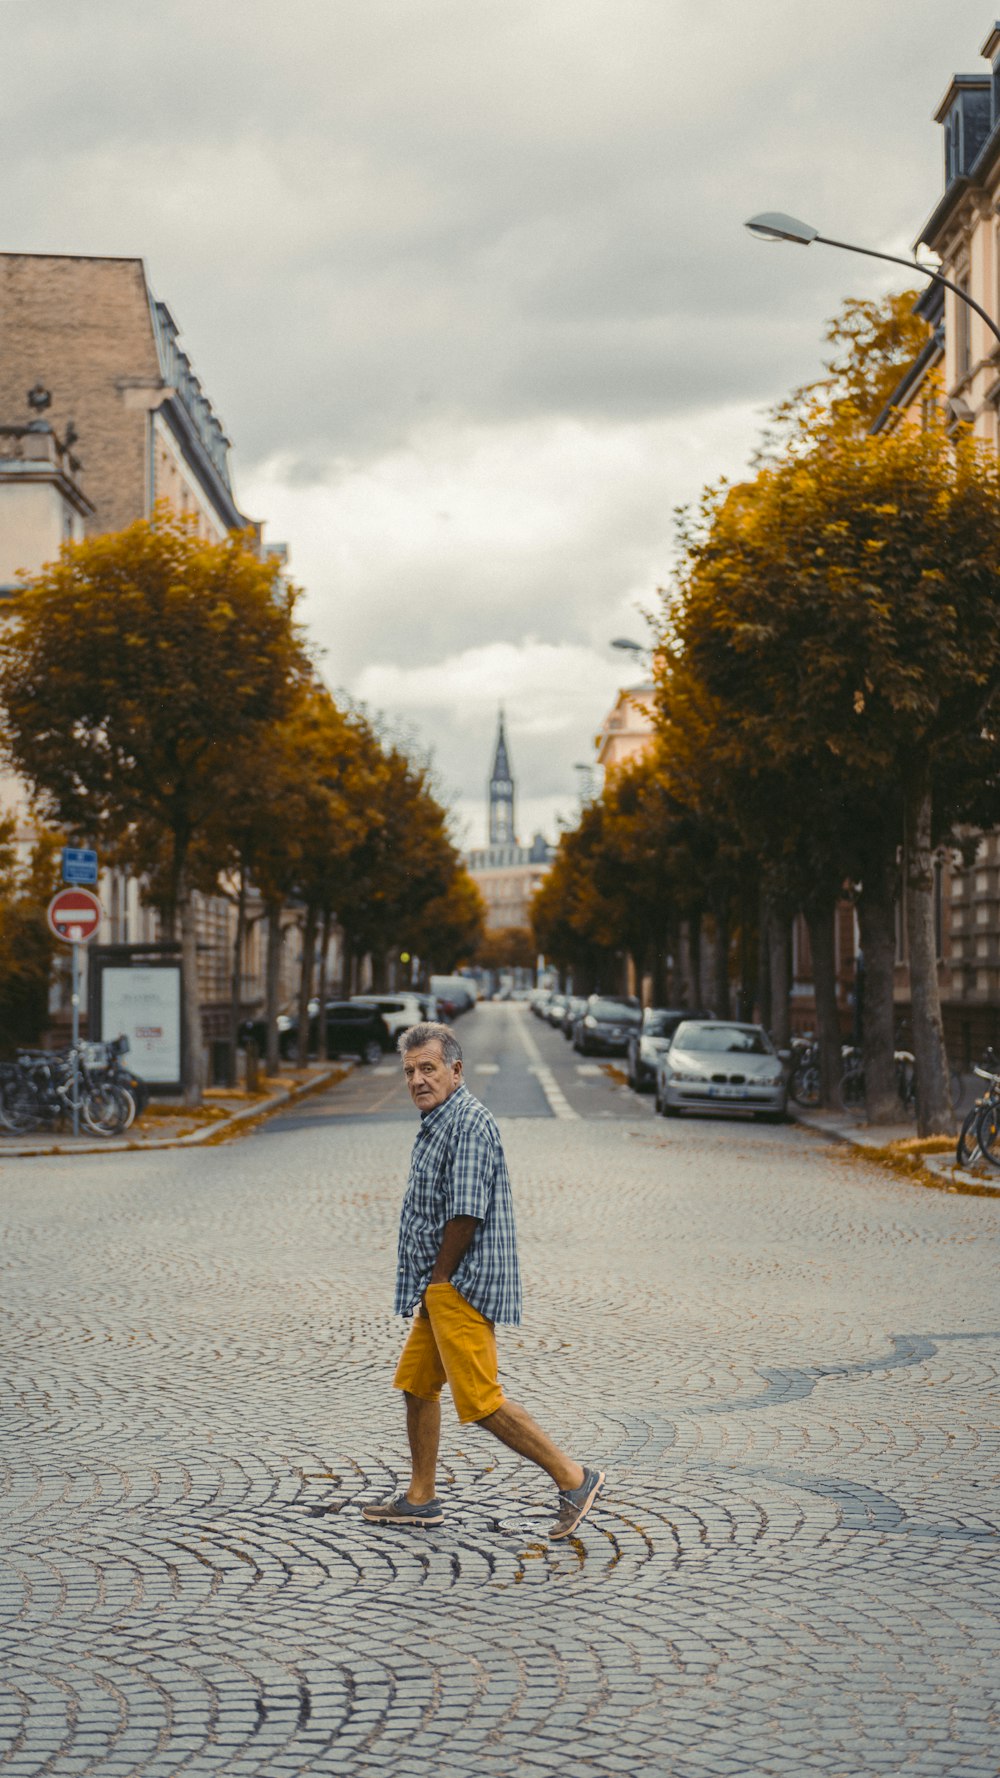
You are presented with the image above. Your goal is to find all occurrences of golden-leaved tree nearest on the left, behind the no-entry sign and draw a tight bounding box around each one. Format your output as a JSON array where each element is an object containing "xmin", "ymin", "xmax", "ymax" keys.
[{"xmin": 0, "ymin": 507, "xmax": 304, "ymax": 1102}]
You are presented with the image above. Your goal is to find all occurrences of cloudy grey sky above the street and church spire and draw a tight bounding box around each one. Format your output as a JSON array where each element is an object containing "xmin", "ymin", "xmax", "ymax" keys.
[{"xmin": 0, "ymin": 0, "xmax": 995, "ymax": 843}]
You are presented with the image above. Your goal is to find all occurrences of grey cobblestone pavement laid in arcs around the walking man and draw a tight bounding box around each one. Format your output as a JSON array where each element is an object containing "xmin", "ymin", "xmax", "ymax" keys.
[{"xmin": 0, "ymin": 1015, "xmax": 1000, "ymax": 1778}]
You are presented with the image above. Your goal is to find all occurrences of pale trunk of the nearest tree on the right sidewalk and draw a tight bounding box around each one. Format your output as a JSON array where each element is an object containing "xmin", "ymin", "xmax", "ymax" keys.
[{"xmin": 904, "ymin": 763, "xmax": 956, "ymax": 1136}]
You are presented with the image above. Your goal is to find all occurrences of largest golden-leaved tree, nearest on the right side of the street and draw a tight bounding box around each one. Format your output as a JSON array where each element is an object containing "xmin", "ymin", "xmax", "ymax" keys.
[{"xmin": 664, "ymin": 428, "xmax": 1000, "ymax": 1133}]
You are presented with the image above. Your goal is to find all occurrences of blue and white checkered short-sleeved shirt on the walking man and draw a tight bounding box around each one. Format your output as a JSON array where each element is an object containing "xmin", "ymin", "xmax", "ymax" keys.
[{"xmin": 395, "ymin": 1085, "xmax": 521, "ymax": 1325}]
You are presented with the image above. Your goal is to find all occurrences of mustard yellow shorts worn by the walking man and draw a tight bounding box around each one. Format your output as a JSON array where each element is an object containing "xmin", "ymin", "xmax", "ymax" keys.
[{"xmin": 393, "ymin": 1284, "xmax": 504, "ymax": 1426}]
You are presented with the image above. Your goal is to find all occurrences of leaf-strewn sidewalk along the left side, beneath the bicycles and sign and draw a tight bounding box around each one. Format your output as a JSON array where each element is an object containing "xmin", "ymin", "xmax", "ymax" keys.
[{"xmin": 0, "ymin": 1058, "xmax": 354, "ymax": 1163}]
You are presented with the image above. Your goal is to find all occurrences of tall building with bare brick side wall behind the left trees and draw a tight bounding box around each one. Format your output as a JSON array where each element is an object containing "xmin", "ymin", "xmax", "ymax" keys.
[{"xmin": 0, "ymin": 252, "xmax": 299, "ymax": 1042}]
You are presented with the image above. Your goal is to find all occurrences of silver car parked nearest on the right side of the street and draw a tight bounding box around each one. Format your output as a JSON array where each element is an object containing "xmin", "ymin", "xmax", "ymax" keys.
[{"xmin": 657, "ymin": 1019, "xmax": 788, "ymax": 1122}]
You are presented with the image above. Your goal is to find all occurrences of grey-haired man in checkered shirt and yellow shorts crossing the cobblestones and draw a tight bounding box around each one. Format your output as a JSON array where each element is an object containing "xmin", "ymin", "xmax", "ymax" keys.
[{"xmin": 363, "ymin": 1024, "xmax": 605, "ymax": 1538}]
